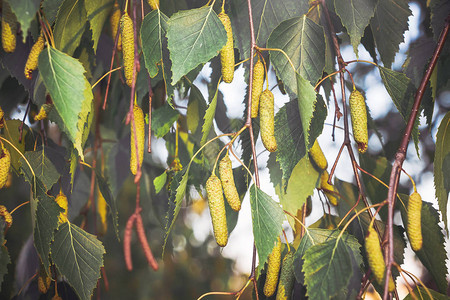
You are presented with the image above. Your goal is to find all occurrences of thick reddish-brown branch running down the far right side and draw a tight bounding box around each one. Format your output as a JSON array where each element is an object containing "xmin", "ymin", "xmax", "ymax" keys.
[{"xmin": 383, "ymin": 14, "xmax": 450, "ymax": 300}]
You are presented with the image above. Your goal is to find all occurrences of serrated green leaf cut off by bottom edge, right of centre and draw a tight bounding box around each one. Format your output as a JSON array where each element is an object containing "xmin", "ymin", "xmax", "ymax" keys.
[{"xmin": 299, "ymin": 231, "xmax": 361, "ymax": 300}]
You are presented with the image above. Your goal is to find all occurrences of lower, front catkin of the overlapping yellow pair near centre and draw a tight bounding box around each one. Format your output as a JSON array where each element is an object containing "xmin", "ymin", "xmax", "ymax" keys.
[{"xmin": 259, "ymin": 90, "xmax": 277, "ymax": 152}]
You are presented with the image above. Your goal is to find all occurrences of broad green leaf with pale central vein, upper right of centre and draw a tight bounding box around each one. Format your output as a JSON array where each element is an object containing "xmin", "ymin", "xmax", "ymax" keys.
[{"xmin": 267, "ymin": 15, "xmax": 325, "ymax": 91}]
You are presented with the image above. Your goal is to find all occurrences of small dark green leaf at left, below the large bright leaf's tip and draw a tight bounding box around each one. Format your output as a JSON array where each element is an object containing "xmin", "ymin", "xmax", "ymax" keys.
[{"xmin": 25, "ymin": 147, "xmax": 60, "ymax": 190}]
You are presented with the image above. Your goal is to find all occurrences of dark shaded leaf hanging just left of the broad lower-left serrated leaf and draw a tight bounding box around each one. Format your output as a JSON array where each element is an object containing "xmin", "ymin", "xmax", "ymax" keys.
[{"xmin": 33, "ymin": 194, "xmax": 63, "ymax": 270}]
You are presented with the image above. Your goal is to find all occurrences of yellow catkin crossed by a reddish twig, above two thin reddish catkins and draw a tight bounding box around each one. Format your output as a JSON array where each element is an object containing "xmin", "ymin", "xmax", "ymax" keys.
[{"xmin": 130, "ymin": 104, "xmax": 145, "ymax": 175}]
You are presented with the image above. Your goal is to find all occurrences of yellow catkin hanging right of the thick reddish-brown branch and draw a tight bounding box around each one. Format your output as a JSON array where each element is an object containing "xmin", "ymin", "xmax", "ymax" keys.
[{"xmin": 406, "ymin": 192, "xmax": 423, "ymax": 251}]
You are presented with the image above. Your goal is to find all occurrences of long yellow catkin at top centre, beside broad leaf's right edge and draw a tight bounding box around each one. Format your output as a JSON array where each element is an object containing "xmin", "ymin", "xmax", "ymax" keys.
[{"xmin": 219, "ymin": 12, "xmax": 234, "ymax": 83}]
